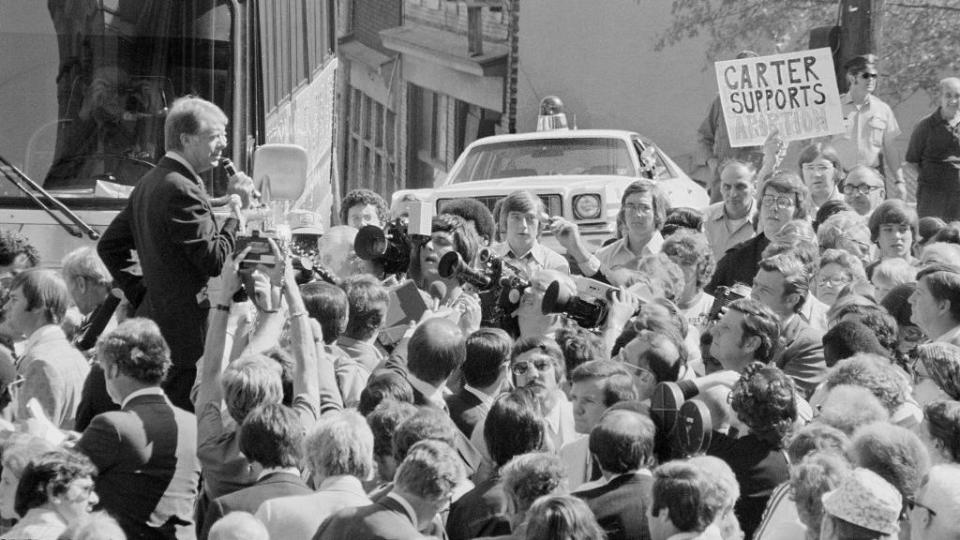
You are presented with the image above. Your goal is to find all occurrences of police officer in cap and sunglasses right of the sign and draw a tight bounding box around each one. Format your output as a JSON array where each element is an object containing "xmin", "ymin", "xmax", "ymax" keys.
[{"xmin": 832, "ymin": 54, "xmax": 906, "ymax": 199}]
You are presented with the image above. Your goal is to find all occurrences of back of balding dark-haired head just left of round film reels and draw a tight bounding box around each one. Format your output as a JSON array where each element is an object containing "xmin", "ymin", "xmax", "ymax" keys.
[{"xmin": 590, "ymin": 410, "xmax": 657, "ymax": 475}]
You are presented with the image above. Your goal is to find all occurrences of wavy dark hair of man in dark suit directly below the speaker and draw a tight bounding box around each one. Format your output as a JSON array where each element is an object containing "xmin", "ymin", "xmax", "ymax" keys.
[{"xmin": 97, "ymin": 318, "xmax": 170, "ymax": 385}]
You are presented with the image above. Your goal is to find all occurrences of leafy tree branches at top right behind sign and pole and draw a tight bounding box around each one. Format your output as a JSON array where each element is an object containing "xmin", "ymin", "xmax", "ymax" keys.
[{"xmin": 654, "ymin": 0, "xmax": 960, "ymax": 105}]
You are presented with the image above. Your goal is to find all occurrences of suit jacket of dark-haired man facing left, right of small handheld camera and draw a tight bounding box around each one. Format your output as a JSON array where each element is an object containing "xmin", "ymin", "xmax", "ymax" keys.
[{"xmin": 773, "ymin": 315, "xmax": 827, "ymax": 398}]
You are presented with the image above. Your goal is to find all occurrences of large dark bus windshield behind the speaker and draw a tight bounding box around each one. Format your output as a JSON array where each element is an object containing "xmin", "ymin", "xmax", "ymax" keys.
[{"xmin": 0, "ymin": 0, "xmax": 234, "ymax": 207}]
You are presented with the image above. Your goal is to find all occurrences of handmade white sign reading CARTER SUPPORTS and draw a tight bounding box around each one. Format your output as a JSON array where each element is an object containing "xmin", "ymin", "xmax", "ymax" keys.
[{"xmin": 716, "ymin": 48, "xmax": 843, "ymax": 148}]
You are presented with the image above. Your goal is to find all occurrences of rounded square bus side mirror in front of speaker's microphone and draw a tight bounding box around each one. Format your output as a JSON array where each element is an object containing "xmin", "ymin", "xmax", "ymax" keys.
[{"xmin": 253, "ymin": 144, "xmax": 307, "ymax": 202}]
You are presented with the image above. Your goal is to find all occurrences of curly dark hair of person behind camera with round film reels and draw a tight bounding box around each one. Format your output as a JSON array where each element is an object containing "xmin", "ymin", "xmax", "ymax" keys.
[{"xmin": 730, "ymin": 362, "xmax": 797, "ymax": 448}]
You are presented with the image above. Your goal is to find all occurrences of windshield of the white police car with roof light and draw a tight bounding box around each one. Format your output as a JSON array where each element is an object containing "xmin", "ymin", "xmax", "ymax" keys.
[{"xmin": 451, "ymin": 137, "xmax": 638, "ymax": 184}]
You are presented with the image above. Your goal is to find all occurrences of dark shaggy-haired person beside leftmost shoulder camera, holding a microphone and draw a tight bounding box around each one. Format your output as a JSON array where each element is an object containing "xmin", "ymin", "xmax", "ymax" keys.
[{"xmin": 407, "ymin": 214, "xmax": 481, "ymax": 334}]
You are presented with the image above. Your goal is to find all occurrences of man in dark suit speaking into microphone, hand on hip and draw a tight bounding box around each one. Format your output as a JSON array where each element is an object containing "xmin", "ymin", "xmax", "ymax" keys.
[{"xmin": 97, "ymin": 96, "xmax": 253, "ymax": 411}]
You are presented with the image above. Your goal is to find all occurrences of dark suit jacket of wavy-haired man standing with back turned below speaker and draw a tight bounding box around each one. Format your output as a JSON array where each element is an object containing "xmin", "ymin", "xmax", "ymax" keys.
[{"xmin": 77, "ymin": 395, "xmax": 200, "ymax": 540}]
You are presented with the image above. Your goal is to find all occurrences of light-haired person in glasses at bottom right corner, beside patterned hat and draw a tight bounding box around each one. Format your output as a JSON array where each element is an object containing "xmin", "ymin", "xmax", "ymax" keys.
[{"xmin": 907, "ymin": 464, "xmax": 960, "ymax": 540}]
